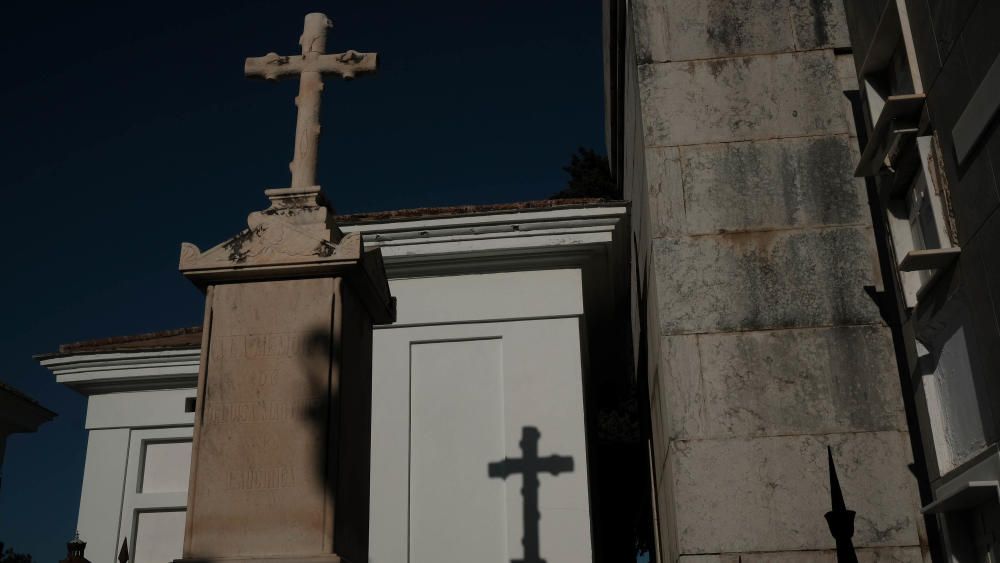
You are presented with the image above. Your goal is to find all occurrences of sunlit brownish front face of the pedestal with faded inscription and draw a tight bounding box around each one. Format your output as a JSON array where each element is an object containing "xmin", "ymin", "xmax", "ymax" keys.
[{"xmin": 188, "ymin": 278, "xmax": 334, "ymax": 557}]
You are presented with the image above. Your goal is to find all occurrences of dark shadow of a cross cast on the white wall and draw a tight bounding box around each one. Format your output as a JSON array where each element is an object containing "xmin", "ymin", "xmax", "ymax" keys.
[{"xmin": 488, "ymin": 426, "xmax": 573, "ymax": 563}]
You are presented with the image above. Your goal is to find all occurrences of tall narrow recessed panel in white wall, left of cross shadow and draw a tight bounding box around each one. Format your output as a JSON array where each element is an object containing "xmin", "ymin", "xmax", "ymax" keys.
[{"xmin": 409, "ymin": 339, "xmax": 507, "ymax": 563}]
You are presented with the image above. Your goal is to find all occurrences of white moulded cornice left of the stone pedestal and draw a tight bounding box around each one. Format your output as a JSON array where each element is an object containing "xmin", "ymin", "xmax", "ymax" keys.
[{"xmin": 39, "ymin": 347, "xmax": 201, "ymax": 395}]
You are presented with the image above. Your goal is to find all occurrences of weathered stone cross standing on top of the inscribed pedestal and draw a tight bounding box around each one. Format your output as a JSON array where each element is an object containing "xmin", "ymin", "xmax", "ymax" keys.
[{"xmin": 243, "ymin": 13, "xmax": 378, "ymax": 188}]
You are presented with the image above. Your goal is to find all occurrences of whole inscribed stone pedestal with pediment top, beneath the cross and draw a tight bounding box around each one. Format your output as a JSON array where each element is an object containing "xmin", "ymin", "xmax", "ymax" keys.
[{"xmin": 174, "ymin": 187, "xmax": 395, "ymax": 563}]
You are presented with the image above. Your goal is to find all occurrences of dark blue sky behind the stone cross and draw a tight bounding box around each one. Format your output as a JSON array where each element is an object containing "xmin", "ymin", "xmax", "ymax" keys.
[{"xmin": 0, "ymin": 0, "xmax": 604, "ymax": 562}]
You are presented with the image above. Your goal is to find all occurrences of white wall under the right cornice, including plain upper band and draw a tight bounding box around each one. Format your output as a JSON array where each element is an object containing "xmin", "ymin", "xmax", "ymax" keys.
[{"xmin": 370, "ymin": 269, "xmax": 591, "ymax": 563}]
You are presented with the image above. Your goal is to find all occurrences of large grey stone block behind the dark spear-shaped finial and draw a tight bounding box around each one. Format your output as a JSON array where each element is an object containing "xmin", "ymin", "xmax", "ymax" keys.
[{"xmin": 668, "ymin": 432, "xmax": 920, "ymax": 554}]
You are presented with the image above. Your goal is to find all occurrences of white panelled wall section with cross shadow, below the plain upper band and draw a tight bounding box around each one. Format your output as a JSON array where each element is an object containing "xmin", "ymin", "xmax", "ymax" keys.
[{"xmin": 370, "ymin": 316, "xmax": 592, "ymax": 563}]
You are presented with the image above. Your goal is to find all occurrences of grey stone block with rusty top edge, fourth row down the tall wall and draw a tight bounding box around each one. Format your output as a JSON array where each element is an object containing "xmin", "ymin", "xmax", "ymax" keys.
[{"xmin": 653, "ymin": 227, "xmax": 881, "ymax": 334}]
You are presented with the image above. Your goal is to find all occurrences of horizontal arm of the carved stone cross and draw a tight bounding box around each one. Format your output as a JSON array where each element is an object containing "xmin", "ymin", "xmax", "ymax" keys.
[{"xmin": 243, "ymin": 50, "xmax": 378, "ymax": 80}]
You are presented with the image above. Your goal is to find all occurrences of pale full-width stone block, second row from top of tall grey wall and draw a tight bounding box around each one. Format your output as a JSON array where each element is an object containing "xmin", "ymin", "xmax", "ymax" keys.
[{"xmin": 639, "ymin": 51, "xmax": 848, "ymax": 148}]
